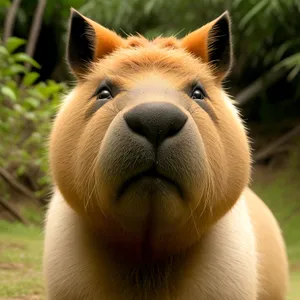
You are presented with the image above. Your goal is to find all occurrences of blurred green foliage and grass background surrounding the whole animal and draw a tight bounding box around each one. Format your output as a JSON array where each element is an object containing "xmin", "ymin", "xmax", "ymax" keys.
[{"xmin": 0, "ymin": 0, "xmax": 300, "ymax": 300}]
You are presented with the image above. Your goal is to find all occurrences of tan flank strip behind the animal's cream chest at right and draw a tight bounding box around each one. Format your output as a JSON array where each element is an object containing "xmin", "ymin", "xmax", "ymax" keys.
[{"xmin": 245, "ymin": 189, "xmax": 288, "ymax": 300}]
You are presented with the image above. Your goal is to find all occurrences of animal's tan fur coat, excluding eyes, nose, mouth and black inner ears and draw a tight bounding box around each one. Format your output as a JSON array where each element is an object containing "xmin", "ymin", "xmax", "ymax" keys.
[{"xmin": 44, "ymin": 9, "xmax": 288, "ymax": 300}]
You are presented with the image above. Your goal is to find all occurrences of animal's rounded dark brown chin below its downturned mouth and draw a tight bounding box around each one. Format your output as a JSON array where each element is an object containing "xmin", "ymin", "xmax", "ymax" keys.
[{"xmin": 115, "ymin": 174, "xmax": 185, "ymax": 236}]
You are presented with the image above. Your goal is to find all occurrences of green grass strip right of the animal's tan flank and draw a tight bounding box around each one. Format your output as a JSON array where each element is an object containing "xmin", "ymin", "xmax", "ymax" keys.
[{"xmin": 252, "ymin": 161, "xmax": 300, "ymax": 300}]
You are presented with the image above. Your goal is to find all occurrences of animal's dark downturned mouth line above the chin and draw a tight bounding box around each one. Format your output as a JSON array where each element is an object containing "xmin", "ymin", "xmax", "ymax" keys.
[{"xmin": 117, "ymin": 167, "xmax": 183, "ymax": 199}]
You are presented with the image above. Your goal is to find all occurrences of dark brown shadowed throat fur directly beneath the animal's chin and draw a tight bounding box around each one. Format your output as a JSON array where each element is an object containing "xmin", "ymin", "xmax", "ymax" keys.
[{"xmin": 91, "ymin": 227, "xmax": 187, "ymax": 299}]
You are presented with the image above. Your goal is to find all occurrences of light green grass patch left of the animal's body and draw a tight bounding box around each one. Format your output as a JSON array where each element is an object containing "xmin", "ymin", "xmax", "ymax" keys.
[{"xmin": 0, "ymin": 221, "xmax": 43, "ymax": 300}]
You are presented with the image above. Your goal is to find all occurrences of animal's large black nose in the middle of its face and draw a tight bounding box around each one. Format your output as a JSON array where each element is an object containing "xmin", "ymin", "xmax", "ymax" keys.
[{"xmin": 124, "ymin": 102, "xmax": 187, "ymax": 147}]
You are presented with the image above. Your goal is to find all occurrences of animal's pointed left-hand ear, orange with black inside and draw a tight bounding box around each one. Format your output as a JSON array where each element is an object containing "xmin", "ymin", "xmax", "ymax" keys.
[{"xmin": 67, "ymin": 9, "xmax": 123, "ymax": 79}]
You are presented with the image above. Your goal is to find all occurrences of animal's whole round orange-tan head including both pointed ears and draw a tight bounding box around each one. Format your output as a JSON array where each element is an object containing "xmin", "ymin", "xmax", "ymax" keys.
[{"xmin": 50, "ymin": 11, "xmax": 250, "ymax": 256}]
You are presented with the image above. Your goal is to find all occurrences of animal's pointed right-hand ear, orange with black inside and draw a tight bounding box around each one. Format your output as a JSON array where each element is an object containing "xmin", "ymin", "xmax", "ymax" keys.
[{"xmin": 181, "ymin": 11, "xmax": 232, "ymax": 81}]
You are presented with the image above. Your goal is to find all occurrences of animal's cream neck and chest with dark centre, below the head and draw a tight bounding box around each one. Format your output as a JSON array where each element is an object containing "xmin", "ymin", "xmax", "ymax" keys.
[{"xmin": 44, "ymin": 194, "xmax": 255, "ymax": 300}]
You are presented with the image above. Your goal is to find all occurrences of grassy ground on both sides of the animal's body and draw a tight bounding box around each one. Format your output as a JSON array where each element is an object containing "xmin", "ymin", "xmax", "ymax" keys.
[{"xmin": 0, "ymin": 165, "xmax": 300, "ymax": 300}]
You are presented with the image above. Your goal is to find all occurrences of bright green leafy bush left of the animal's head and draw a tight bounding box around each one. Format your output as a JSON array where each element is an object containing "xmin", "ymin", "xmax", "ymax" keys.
[{"xmin": 0, "ymin": 37, "xmax": 66, "ymax": 195}]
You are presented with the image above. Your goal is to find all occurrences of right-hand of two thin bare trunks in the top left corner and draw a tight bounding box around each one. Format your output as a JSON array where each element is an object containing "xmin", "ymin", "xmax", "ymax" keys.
[{"xmin": 26, "ymin": 0, "xmax": 47, "ymax": 70}]
